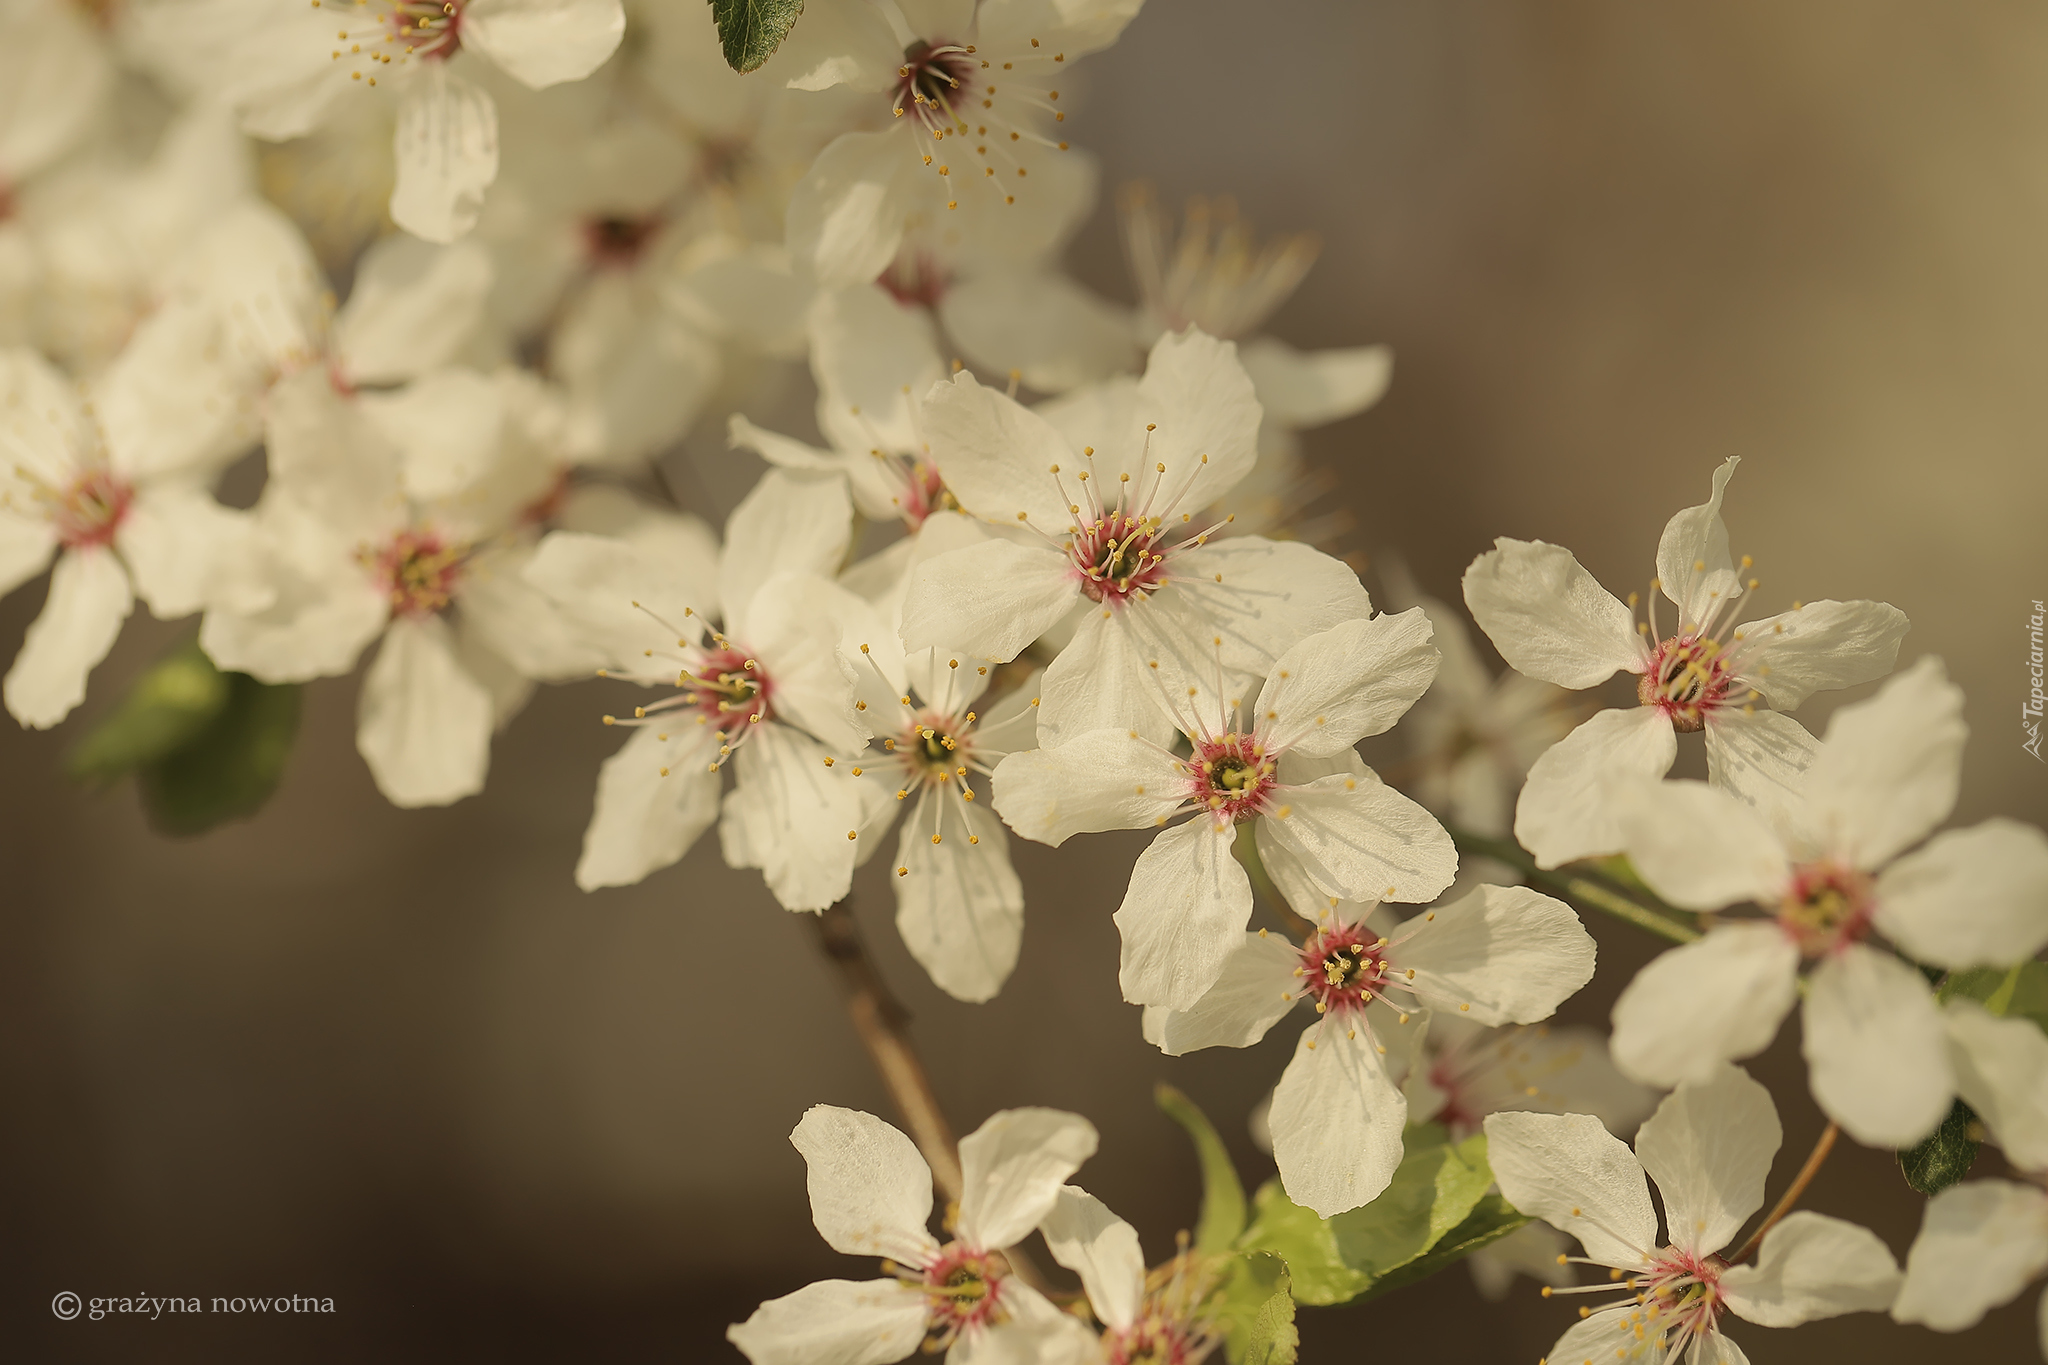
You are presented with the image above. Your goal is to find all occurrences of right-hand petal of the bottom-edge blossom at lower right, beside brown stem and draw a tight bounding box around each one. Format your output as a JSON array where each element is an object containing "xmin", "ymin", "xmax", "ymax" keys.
[{"xmin": 1720, "ymin": 1209, "xmax": 1901, "ymax": 1326}]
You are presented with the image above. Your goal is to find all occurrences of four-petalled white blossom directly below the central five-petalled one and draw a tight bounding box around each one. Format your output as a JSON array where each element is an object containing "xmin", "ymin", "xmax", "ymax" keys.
[{"xmin": 991, "ymin": 609, "xmax": 1458, "ymax": 1009}]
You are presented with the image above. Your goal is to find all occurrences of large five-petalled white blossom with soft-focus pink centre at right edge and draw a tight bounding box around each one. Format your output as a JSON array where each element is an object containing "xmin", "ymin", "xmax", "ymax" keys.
[{"xmin": 1614, "ymin": 659, "xmax": 2048, "ymax": 1148}]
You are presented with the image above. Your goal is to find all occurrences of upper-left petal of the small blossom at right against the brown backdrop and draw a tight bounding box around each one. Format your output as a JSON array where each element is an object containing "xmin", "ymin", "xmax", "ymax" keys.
[{"xmin": 1464, "ymin": 536, "xmax": 1645, "ymax": 688}]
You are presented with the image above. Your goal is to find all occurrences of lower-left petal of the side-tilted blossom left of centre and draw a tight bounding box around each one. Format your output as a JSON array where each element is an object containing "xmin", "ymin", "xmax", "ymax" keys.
[{"xmin": 575, "ymin": 716, "xmax": 719, "ymax": 890}]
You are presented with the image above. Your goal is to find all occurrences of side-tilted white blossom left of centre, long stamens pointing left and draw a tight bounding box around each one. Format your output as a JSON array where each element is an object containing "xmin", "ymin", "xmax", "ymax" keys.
[{"xmin": 524, "ymin": 471, "xmax": 889, "ymax": 911}]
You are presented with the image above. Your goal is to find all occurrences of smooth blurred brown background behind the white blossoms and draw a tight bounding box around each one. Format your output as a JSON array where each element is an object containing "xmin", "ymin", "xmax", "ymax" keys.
[{"xmin": 0, "ymin": 0, "xmax": 2048, "ymax": 1365}]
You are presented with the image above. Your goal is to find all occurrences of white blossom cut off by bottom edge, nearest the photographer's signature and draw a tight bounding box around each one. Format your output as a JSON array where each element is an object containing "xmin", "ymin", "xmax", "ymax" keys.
[{"xmin": 725, "ymin": 1105, "xmax": 1096, "ymax": 1365}]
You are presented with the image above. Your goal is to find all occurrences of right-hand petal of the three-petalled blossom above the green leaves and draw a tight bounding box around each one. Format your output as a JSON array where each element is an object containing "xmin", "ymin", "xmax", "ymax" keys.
[{"xmin": 1380, "ymin": 886, "xmax": 1593, "ymax": 1025}]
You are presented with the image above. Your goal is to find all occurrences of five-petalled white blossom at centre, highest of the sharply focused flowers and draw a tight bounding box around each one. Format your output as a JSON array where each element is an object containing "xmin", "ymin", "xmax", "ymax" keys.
[{"xmin": 903, "ymin": 332, "xmax": 1372, "ymax": 745}]
